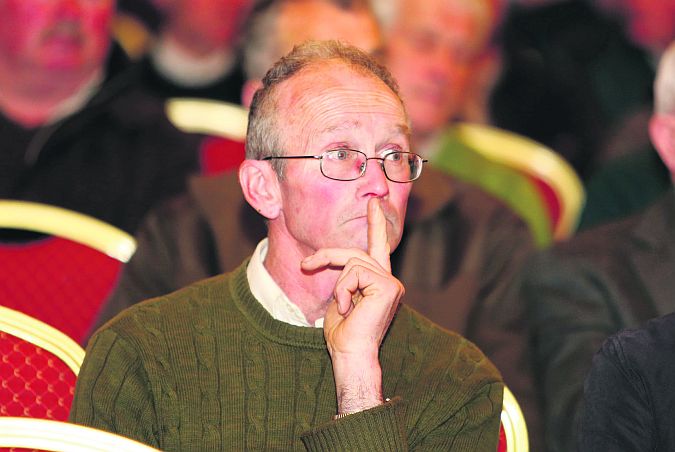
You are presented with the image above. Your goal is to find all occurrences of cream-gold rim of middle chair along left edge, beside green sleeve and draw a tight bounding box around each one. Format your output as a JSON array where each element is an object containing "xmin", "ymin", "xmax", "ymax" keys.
[{"xmin": 0, "ymin": 306, "xmax": 84, "ymax": 375}]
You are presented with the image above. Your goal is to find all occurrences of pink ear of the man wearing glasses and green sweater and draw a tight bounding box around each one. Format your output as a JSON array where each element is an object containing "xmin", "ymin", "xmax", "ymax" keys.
[{"xmin": 239, "ymin": 159, "xmax": 281, "ymax": 220}]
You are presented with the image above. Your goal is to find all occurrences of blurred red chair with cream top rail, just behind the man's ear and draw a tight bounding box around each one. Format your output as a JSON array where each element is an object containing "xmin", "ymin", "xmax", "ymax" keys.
[{"xmin": 166, "ymin": 98, "xmax": 248, "ymax": 176}]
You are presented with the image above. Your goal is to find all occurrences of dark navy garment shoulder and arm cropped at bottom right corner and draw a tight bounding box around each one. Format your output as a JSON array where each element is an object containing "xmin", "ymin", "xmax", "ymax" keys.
[{"xmin": 579, "ymin": 314, "xmax": 675, "ymax": 452}]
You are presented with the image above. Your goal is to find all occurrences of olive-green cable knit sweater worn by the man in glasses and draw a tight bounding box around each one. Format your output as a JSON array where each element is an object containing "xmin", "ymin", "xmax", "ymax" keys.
[{"xmin": 70, "ymin": 263, "xmax": 503, "ymax": 452}]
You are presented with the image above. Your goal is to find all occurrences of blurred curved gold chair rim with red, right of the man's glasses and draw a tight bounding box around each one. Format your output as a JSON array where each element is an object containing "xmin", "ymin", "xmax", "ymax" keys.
[{"xmin": 446, "ymin": 123, "xmax": 585, "ymax": 240}]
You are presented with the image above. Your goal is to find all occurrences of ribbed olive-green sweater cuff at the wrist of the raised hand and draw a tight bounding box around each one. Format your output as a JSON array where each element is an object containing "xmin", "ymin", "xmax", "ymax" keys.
[{"xmin": 301, "ymin": 397, "xmax": 408, "ymax": 451}]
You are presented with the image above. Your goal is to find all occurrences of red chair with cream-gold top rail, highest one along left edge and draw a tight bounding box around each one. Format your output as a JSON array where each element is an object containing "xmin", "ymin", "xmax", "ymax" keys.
[{"xmin": 0, "ymin": 200, "xmax": 136, "ymax": 342}]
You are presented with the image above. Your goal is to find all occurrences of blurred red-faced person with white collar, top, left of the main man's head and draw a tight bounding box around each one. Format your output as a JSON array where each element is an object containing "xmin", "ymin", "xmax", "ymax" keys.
[{"xmin": 135, "ymin": 0, "xmax": 253, "ymax": 104}]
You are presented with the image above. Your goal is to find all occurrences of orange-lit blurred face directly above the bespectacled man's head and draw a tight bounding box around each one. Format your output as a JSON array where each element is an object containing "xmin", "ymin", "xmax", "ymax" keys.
[{"xmin": 278, "ymin": 1, "xmax": 381, "ymax": 54}]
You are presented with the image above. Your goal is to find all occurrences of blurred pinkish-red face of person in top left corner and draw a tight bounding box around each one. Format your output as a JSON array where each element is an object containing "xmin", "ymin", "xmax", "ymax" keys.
[{"xmin": 0, "ymin": 0, "xmax": 115, "ymax": 72}]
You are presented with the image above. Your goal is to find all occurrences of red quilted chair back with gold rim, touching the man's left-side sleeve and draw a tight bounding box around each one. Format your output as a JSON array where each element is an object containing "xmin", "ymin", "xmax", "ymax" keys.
[{"xmin": 0, "ymin": 306, "xmax": 84, "ymax": 420}]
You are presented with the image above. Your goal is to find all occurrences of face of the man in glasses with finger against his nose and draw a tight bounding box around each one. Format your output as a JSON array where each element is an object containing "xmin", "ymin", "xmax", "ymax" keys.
[{"xmin": 270, "ymin": 63, "xmax": 412, "ymax": 255}]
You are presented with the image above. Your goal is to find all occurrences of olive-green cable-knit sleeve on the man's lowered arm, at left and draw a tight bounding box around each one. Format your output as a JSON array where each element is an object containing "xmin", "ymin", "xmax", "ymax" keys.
[{"xmin": 69, "ymin": 329, "xmax": 159, "ymax": 447}]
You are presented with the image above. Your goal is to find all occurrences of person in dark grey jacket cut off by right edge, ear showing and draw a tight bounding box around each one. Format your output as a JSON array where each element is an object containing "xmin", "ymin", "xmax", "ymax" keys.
[{"xmin": 522, "ymin": 44, "xmax": 675, "ymax": 452}]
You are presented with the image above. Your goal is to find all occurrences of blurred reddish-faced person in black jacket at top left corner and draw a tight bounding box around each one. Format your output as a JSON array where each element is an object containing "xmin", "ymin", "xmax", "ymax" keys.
[{"xmin": 0, "ymin": 0, "xmax": 196, "ymax": 233}]
